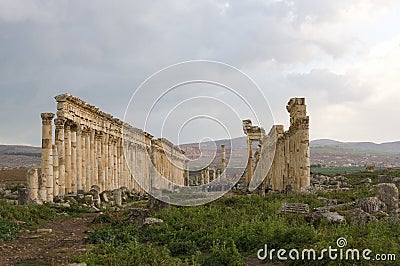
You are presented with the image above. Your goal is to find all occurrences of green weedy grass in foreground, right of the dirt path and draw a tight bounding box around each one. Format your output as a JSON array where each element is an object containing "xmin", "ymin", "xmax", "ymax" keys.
[{"xmin": 79, "ymin": 189, "xmax": 400, "ymax": 265}]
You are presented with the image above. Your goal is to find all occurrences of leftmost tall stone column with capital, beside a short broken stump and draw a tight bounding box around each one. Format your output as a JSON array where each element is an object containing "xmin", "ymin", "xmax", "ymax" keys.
[{"xmin": 39, "ymin": 113, "xmax": 54, "ymax": 201}]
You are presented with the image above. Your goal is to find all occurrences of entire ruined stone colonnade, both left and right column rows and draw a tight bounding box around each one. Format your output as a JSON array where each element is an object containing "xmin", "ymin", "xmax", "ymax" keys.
[{"xmin": 25, "ymin": 94, "xmax": 310, "ymax": 203}]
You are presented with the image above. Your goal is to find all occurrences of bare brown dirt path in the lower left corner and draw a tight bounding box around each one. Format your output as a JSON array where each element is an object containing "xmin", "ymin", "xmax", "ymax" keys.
[{"xmin": 0, "ymin": 213, "xmax": 98, "ymax": 266}]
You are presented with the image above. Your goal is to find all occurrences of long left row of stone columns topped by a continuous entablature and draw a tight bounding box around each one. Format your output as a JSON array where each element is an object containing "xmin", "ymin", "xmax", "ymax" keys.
[{"xmin": 28, "ymin": 94, "xmax": 185, "ymax": 202}]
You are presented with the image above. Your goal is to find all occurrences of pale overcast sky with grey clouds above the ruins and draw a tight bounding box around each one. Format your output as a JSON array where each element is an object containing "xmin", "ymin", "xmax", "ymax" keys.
[{"xmin": 0, "ymin": 0, "xmax": 400, "ymax": 146}]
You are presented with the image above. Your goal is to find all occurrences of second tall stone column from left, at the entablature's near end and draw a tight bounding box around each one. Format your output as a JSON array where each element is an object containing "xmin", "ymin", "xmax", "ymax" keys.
[{"xmin": 54, "ymin": 118, "xmax": 65, "ymax": 195}]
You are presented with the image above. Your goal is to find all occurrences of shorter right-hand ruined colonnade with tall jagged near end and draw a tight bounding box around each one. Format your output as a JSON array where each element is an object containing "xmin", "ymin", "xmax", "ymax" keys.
[{"xmin": 243, "ymin": 98, "xmax": 310, "ymax": 194}]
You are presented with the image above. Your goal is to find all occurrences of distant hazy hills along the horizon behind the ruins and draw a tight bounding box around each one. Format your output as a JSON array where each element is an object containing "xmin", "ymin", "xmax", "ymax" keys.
[{"xmin": 0, "ymin": 137, "xmax": 400, "ymax": 169}]
